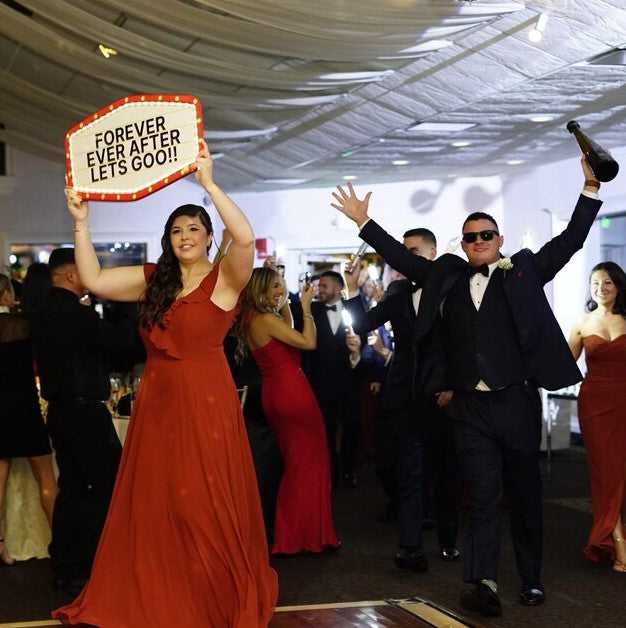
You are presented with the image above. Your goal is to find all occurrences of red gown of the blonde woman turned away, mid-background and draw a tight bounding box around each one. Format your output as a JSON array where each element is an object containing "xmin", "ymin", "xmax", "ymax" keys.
[{"xmin": 252, "ymin": 339, "xmax": 339, "ymax": 554}]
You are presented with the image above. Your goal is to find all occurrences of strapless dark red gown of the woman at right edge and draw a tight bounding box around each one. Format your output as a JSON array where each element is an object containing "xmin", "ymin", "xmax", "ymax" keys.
[{"xmin": 578, "ymin": 334, "xmax": 626, "ymax": 562}]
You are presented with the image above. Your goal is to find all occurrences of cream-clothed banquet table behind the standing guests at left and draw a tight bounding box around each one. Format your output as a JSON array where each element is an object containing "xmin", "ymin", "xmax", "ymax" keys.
[{"xmin": 0, "ymin": 416, "xmax": 129, "ymax": 560}]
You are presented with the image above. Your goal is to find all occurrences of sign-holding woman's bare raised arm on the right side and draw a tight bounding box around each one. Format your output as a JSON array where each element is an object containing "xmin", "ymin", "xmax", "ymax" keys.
[{"xmin": 195, "ymin": 141, "xmax": 254, "ymax": 296}]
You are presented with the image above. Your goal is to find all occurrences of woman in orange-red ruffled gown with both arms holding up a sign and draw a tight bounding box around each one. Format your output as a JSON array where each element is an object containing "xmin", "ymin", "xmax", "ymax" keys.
[{"xmin": 53, "ymin": 143, "xmax": 277, "ymax": 628}]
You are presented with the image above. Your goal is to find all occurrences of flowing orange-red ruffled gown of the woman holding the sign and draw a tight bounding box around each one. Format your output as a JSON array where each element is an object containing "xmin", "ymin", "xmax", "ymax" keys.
[{"xmin": 53, "ymin": 266, "xmax": 277, "ymax": 628}]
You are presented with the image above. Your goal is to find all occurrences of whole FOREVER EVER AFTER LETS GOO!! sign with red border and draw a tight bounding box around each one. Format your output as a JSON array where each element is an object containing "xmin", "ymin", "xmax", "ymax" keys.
[{"xmin": 65, "ymin": 94, "xmax": 202, "ymax": 201}]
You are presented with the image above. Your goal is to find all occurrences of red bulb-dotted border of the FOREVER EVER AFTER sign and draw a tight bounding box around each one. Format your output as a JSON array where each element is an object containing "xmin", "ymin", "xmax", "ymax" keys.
[{"xmin": 65, "ymin": 94, "xmax": 204, "ymax": 201}]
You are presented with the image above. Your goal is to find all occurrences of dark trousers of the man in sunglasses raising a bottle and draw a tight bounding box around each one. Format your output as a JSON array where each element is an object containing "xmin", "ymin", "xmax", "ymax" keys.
[{"xmin": 449, "ymin": 383, "xmax": 543, "ymax": 584}]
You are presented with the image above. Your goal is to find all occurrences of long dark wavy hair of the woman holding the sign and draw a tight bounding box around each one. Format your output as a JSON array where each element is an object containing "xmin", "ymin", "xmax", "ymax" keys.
[{"xmin": 139, "ymin": 204, "xmax": 213, "ymax": 329}]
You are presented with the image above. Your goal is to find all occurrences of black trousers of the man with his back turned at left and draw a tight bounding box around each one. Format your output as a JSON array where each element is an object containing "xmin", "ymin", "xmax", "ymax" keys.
[{"xmin": 48, "ymin": 401, "xmax": 122, "ymax": 580}]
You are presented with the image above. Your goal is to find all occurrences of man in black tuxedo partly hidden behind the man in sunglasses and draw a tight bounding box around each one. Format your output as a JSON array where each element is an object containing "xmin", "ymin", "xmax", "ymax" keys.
[{"xmin": 345, "ymin": 228, "xmax": 459, "ymax": 571}]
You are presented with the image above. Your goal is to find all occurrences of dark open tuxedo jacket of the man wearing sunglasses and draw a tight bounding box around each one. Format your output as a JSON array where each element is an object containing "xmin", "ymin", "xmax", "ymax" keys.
[{"xmin": 359, "ymin": 194, "xmax": 602, "ymax": 390}]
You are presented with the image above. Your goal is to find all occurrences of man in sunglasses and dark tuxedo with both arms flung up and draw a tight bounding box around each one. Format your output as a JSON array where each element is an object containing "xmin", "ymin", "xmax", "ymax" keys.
[{"xmin": 332, "ymin": 157, "xmax": 602, "ymax": 615}]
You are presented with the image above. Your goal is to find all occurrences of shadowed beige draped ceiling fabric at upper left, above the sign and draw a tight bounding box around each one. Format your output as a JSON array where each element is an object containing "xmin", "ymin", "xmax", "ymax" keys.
[{"xmin": 0, "ymin": 0, "xmax": 521, "ymax": 167}]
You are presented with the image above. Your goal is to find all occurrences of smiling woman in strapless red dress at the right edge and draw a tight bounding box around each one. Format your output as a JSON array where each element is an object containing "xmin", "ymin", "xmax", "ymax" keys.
[{"xmin": 569, "ymin": 262, "xmax": 626, "ymax": 573}]
